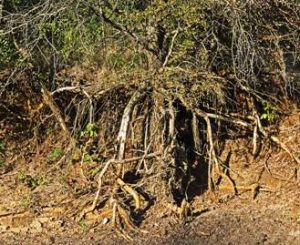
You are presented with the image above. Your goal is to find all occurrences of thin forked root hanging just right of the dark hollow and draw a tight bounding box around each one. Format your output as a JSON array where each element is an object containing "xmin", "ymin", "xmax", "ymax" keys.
[{"xmin": 204, "ymin": 116, "xmax": 237, "ymax": 194}]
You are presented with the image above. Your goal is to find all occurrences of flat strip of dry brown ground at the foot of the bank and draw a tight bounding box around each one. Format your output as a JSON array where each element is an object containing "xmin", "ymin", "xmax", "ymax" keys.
[{"xmin": 0, "ymin": 189, "xmax": 300, "ymax": 245}]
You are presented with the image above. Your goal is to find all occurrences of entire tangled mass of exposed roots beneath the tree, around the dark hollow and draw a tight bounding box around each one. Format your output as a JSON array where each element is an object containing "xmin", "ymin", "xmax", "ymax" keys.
[{"xmin": 4, "ymin": 81, "xmax": 300, "ymax": 237}]
